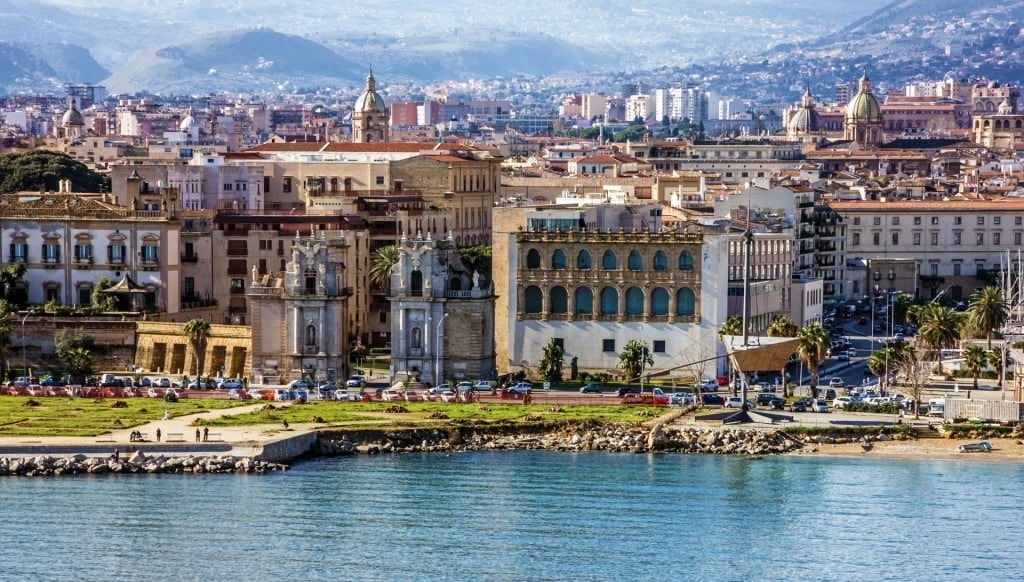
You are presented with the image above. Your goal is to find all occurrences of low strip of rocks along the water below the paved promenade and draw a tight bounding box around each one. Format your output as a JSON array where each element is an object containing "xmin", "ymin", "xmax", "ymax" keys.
[{"xmin": 0, "ymin": 451, "xmax": 289, "ymax": 476}]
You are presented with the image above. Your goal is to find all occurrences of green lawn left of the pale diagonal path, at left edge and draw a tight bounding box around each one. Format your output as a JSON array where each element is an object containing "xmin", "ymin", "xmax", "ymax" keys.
[{"xmin": 0, "ymin": 396, "xmax": 244, "ymax": 437}]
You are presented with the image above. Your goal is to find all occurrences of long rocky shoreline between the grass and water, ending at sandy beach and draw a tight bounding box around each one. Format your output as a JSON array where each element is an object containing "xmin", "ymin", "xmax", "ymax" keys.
[{"xmin": 314, "ymin": 424, "xmax": 804, "ymax": 455}]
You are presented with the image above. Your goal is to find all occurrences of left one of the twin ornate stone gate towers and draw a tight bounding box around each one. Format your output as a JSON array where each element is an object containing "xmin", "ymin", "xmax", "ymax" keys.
[{"xmin": 246, "ymin": 231, "xmax": 352, "ymax": 383}]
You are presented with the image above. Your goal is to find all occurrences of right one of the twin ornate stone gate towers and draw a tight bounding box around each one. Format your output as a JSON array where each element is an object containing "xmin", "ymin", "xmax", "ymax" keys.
[{"xmin": 388, "ymin": 234, "xmax": 495, "ymax": 385}]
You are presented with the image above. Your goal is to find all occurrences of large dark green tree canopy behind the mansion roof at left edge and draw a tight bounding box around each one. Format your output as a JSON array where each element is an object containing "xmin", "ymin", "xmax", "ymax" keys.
[{"xmin": 0, "ymin": 150, "xmax": 111, "ymax": 192}]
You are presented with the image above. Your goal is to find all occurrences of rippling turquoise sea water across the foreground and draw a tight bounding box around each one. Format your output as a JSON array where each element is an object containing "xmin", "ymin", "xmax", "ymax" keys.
[{"xmin": 0, "ymin": 451, "xmax": 1024, "ymax": 581}]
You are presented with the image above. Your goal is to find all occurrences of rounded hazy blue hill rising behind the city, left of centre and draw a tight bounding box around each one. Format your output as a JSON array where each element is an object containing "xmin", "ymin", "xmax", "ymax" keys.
[{"xmin": 102, "ymin": 29, "xmax": 367, "ymax": 93}]
